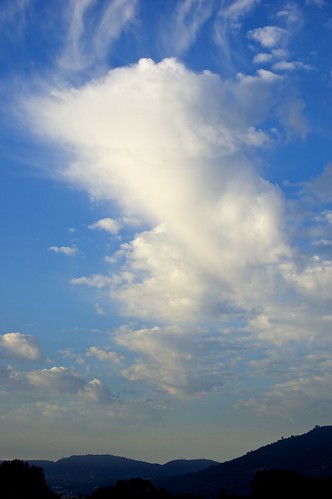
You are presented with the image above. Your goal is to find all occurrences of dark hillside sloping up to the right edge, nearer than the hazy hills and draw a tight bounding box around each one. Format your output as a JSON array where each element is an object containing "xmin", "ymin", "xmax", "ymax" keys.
[{"xmin": 153, "ymin": 426, "xmax": 332, "ymax": 498}]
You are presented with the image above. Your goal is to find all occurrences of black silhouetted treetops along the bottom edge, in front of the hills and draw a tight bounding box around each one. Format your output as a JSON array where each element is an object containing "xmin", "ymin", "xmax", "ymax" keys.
[{"xmin": 0, "ymin": 460, "xmax": 332, "ymax": 499}]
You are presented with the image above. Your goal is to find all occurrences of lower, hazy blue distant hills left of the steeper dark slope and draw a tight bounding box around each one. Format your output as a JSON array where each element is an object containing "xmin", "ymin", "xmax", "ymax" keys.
[{"xmin": 29, "ymin": 454, "xmax": 218, "ymax": 495}]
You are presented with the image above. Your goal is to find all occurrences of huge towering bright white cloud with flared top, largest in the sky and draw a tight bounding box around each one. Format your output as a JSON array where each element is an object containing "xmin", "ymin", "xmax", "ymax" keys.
[{"xmin": 25, "ymin": 59, "xmax": 289, "ymax": 320}]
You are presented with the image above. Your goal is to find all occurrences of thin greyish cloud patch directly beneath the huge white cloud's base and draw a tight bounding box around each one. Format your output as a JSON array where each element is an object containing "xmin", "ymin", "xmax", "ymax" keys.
[{"xmin": 115, "ymin": 326, "xmax": 223, "ymax": 397}]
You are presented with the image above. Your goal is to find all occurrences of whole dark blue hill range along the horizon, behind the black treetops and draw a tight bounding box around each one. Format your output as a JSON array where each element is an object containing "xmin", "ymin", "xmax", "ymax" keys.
[{"xmin": 1, "ymin": 426, "xmax": 332, "ymax": 499}]
